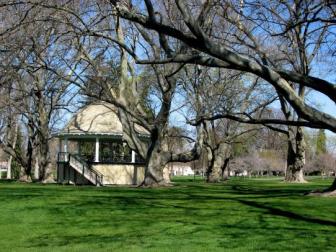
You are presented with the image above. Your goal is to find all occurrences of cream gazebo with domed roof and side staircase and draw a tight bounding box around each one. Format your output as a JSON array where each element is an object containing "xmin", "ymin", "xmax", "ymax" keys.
[{"xmin": 56, "ymin": 103, "xmax": 149, "ymax": 185}]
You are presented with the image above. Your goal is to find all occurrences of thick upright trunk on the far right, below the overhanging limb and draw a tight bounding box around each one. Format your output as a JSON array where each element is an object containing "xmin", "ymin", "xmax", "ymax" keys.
[{"xmin": 285, "ymin": 127, "xmax": 306, "ymax": 183}]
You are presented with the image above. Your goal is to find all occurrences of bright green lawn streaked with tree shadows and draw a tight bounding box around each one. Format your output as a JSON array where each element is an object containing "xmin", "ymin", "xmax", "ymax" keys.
[{"xmin": 0, "ymin": 178, "xmax": 336, "ymax": 251}]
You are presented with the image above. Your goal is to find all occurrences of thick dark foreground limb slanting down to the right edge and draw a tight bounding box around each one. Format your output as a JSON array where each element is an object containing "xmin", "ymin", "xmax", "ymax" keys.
[{"xmin": 109, "ymin": 1, "xmax": 336, "ymax": 131}]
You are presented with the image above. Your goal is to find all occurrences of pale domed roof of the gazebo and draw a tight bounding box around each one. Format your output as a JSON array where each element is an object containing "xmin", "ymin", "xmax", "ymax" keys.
[{"xmin": 57, "ymin": 102, "xmax": 149, "ymax": 138}]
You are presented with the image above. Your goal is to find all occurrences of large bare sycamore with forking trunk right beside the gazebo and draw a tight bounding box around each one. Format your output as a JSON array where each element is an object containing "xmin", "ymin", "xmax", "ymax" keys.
[{"xmin": 6, "ymin": 1, "xmax": 203, "ymax": 186}]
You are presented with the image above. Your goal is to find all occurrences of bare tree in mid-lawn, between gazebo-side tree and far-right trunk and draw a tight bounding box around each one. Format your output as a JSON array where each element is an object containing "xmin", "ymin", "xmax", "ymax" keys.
[{"xmin": 183, "ymin": 64, "xmax": 276, "ymax": 182}]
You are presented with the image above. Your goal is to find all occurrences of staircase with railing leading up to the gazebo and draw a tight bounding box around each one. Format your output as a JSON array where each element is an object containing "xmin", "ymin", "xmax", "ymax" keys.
[{"xmin": 58, "ymin": 152, "xmax": 104, "ymax": 186}]
